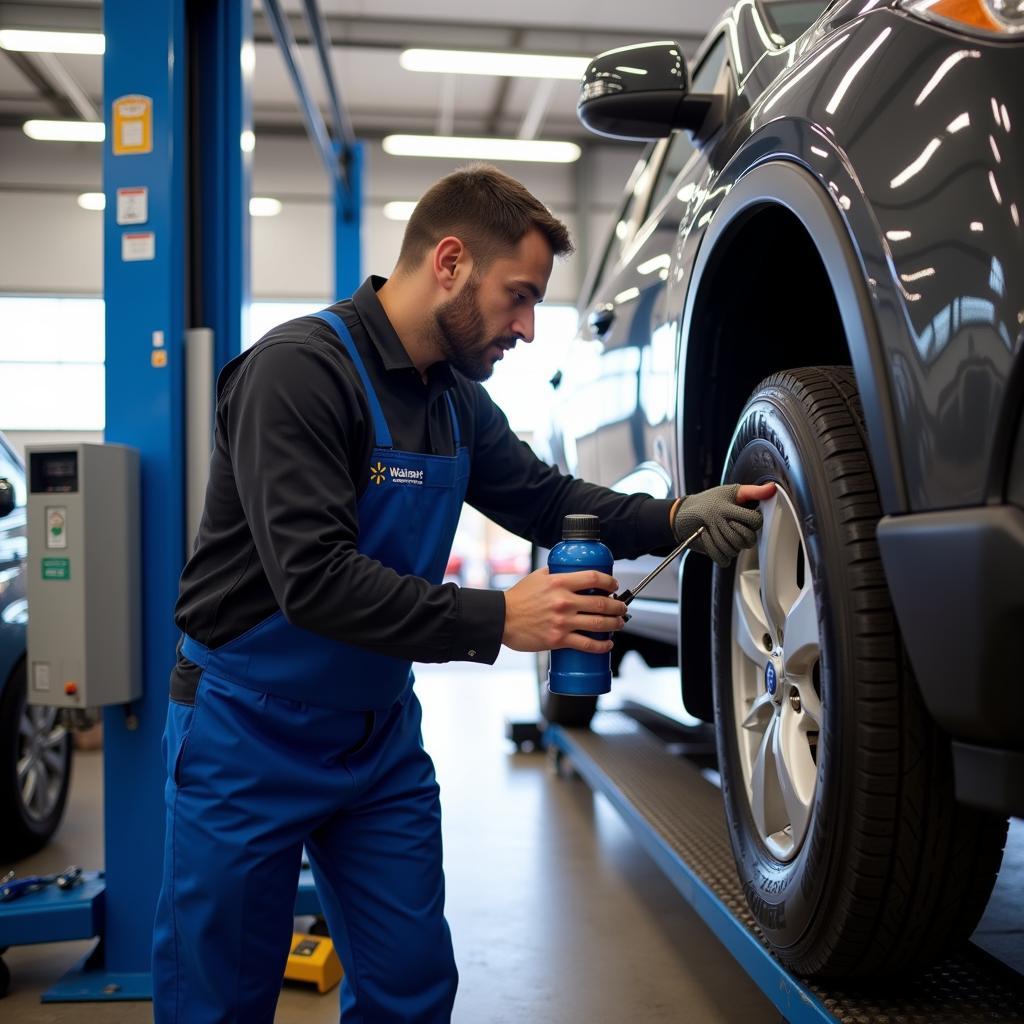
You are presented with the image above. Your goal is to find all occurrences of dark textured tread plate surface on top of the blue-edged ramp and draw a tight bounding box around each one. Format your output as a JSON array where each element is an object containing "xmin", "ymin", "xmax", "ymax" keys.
[{"xmin": 562, "ymin": 713, "xmax": 1024, "ymax": 1024}]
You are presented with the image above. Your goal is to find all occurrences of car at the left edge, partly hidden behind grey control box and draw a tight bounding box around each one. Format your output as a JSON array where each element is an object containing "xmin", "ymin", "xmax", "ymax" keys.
[{"xmin": 0, "ymin": 435, "xmax": 72, "ymax": 865}]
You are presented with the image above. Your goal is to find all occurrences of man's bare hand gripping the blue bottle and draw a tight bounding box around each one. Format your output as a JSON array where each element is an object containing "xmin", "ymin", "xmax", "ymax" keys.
[{"xmin": 502, "ymin": 567, "xmax": 626, "ymax": 654}]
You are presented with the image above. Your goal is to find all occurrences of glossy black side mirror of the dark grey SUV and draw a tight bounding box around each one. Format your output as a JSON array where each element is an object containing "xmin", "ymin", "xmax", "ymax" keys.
[{"xmin": 577, "ymin": 40, "xmax": 724, "ymax": 140}]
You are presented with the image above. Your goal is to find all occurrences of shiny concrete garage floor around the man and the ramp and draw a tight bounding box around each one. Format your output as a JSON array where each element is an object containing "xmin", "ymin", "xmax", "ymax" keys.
[{"xmin": 0, "ymin": 654, "xmax": 1024, "ymax": 1024}]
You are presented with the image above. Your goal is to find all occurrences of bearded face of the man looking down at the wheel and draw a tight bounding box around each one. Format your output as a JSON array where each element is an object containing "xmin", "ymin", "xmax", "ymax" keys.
[{"xmin": 434, "ymin": 229, "xmax": 554, "ymax": 381}]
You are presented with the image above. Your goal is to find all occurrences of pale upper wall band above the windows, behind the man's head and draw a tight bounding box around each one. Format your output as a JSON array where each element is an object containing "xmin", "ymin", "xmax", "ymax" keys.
[{"xmin": 0, "ymin": 128, "xmax": 637, "ymax": 302}]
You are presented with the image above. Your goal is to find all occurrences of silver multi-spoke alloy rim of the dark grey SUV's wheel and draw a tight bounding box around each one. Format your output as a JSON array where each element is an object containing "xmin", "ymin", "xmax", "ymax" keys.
[{"xmin": 732, "ymin": 487, "xmax": 822, "ymax": 861}]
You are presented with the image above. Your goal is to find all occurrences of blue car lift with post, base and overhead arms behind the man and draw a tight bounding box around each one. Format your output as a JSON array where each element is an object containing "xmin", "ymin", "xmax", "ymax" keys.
[{"xmin": 0, "ymin": 0, "xmax": 361, "ymax": 1002}]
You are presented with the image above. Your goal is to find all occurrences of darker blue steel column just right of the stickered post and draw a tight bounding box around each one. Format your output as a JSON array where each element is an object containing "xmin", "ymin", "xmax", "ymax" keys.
[{"xmin": 188, "ymin": 0, "xmax": 254, "ymax": 372}]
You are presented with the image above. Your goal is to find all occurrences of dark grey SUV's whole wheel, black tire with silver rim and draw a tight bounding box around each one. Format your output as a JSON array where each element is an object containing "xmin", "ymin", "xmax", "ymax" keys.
[{"xmin": 712, "ymin": 367, "xmax": 1007, "ymax": 977}]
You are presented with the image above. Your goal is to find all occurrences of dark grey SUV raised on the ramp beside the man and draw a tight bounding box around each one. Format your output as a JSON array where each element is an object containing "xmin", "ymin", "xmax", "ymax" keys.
[{"xmin": 536, "ymin": 0, "xmax": 1024, "ymax": 976}]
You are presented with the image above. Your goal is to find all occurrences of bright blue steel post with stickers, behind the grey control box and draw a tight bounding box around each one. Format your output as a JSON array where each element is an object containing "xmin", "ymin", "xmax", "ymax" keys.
[{"xmin": 103, "ymin": 0, "xmax": 186, "ymax": 997}]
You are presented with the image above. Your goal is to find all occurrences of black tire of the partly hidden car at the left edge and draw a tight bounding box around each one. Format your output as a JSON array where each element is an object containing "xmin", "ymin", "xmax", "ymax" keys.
[{"xmin": 0, "ymin": 662, "xmax": 72, "ymax": 862}]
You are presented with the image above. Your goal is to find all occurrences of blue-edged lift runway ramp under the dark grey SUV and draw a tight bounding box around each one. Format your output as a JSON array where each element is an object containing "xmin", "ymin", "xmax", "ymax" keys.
[{"xmin": 545, "ymin": 712, "xmax": 1024, "ymax": 1024}]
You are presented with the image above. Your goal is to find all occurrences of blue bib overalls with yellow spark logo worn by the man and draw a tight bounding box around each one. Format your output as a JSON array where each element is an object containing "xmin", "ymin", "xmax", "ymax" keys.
[{"xmin": 153, "ymin": 310, "xmax": 469, "ymax": 1024}]
